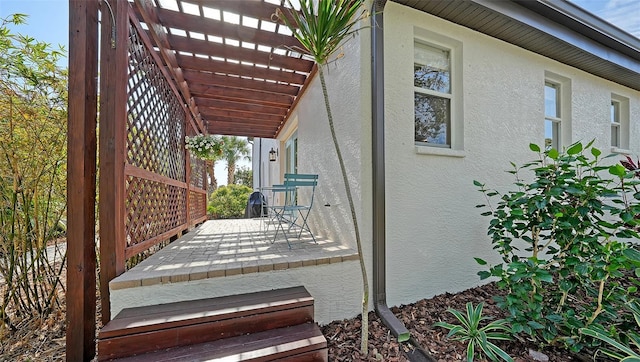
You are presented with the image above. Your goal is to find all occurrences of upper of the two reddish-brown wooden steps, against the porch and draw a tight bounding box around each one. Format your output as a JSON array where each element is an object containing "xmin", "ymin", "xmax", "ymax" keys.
[{"xmin": 98, "ymin": 287, "xmax": 314, "ymax": 361}]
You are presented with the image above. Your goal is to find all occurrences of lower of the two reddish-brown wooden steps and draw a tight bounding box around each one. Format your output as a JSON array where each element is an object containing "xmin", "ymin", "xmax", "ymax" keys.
[{"xmin": 111, "ymin": 323, "xmax": 328, "ymax": 362}]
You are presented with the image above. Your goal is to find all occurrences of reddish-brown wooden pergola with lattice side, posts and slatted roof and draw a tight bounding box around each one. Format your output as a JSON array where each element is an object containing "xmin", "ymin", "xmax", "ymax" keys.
[{"xmin": 67, "ymin": 0, "xmax": 315, "ymax": 361}]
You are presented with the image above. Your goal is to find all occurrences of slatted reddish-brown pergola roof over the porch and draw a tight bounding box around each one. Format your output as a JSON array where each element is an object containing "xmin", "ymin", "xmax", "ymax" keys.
[{"xmin": 130, "ymin": 0, "xmax": 314, "ymax": 138}]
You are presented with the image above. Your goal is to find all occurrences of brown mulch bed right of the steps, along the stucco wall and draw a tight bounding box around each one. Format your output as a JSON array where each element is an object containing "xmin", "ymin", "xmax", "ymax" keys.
[{"xmin": 322, "ymin": 283, "xmax": 593, "ymax": 362}]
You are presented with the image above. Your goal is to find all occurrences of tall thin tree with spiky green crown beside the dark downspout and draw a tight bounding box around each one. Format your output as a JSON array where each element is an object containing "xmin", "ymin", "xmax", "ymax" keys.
[{"xmin": 276, "ymin": 0, "xmax": 369, "ymax": 354}]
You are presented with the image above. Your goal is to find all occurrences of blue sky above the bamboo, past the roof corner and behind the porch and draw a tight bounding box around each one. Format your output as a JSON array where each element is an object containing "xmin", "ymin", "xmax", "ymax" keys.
[{"xmin": 0, "ymin": 0, "xmax": 640, "ymax": 185}]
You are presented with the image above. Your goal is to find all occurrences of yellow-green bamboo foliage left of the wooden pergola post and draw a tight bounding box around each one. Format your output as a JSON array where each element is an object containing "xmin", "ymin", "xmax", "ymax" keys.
[{"xmin": 0, "ymin": 14, "xmax": 67, "ymax": 326}]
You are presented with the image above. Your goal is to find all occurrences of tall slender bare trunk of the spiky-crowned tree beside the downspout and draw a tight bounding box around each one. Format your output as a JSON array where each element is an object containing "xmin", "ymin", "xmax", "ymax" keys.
[{"xmin": 318, "ymin": 65, "xmax": 369, "ymax": 355}]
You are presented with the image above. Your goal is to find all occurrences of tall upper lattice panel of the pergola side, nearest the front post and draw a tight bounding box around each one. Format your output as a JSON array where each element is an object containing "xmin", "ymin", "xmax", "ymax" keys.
[{"xmin": 127, "ymin": 21, "xmax": 186, "ymax": 182}]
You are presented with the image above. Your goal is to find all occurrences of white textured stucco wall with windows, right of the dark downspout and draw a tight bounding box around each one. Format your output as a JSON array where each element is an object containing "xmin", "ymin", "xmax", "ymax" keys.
[{"xmin": 380, "ymin": 2, "xmax": 640, "ymax": 305}]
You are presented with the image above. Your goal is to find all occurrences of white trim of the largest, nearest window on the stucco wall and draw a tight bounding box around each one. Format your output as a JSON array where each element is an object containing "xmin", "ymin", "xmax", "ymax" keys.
[{"xmin": 411, "ymin": 27, "xmax": 465, "ymax": 157}]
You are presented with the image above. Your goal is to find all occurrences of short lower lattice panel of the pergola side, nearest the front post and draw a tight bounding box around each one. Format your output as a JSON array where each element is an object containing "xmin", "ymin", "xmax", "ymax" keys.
[{"xmin": 125, "ymin": 176, "xmax": 187, "ymax": 246}]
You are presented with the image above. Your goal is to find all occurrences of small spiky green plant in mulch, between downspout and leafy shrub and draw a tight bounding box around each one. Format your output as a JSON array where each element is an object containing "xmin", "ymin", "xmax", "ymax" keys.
[{"xmin": 434, "ymin": 302, "xmax": 513, "ymax": 362}]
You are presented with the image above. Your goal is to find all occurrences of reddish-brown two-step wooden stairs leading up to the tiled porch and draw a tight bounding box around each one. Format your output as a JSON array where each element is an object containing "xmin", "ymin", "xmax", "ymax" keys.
[{"xmin": 98, "ymin": 287, "xmax": 326, "ymax": 361}]
